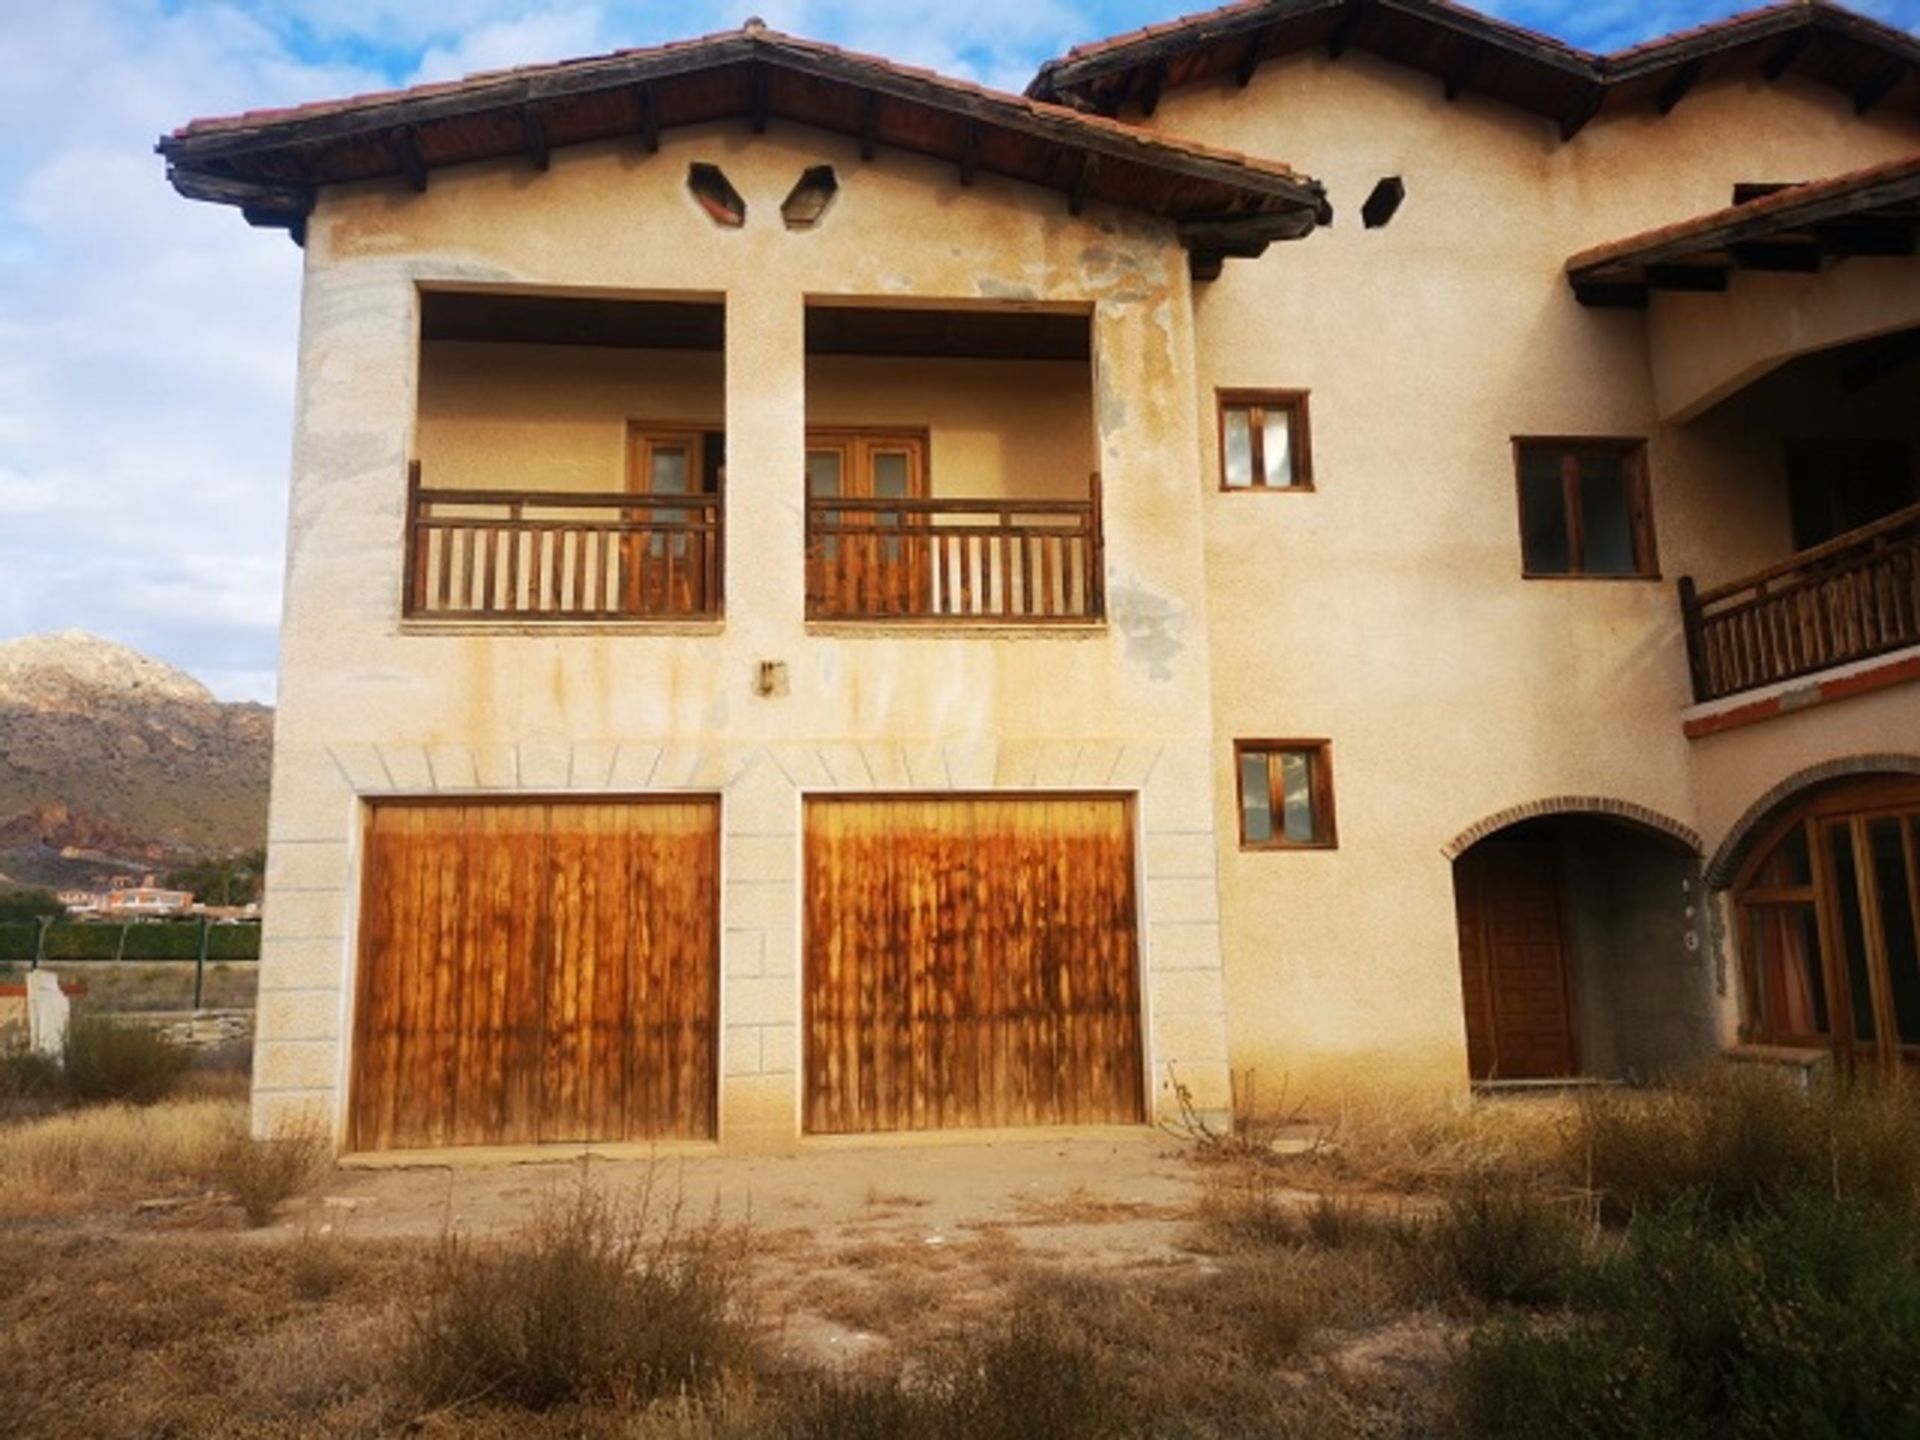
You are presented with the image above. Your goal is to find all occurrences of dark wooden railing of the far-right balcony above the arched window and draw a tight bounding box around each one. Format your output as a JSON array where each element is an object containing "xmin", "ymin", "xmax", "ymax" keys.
[{"xmin": 1680, "ymin": 505, "xmax": 1920, "ymax": 701}]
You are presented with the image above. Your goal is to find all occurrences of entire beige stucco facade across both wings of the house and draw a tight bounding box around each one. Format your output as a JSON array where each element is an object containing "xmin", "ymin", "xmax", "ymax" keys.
[{"xmin": 255, "ymin": 54, "xmax": 1920, "ymax": 1144}]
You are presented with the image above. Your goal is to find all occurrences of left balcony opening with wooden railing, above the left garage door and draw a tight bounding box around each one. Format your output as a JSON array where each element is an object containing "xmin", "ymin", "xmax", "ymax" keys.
[{"xmin": 403, "ymin": 290, "xmax": 726, "ymax": 624}]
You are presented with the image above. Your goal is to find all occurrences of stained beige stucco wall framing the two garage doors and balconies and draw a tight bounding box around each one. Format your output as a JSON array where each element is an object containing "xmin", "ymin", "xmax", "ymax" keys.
[{"xmin": 255, "ymin": 115, "xmax": 1227, "ymax": 1144}]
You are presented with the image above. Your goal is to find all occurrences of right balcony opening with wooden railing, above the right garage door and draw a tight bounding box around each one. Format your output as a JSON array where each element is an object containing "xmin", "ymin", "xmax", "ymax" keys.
[{"xmin": 806, "ymin": 301, "xmax": 1104, "ymax": 624}]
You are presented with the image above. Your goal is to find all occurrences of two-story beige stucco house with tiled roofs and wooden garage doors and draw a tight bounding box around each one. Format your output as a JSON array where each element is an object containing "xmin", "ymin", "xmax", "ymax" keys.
[{"xmin": 159, "ymin": 0, "xmax": 1920, "ymax": 1152}]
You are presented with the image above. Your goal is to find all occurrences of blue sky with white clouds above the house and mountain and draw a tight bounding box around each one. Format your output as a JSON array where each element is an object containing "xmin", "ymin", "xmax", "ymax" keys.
[{"xmin": 0, "ymin": 0, "xmax": 1920, "ymax": 699}]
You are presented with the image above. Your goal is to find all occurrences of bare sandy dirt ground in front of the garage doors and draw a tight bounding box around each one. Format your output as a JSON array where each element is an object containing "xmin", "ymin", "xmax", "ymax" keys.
[{"xmin": 280, "ymin": 1129, "xmax": 1213, "ymax": 1361}]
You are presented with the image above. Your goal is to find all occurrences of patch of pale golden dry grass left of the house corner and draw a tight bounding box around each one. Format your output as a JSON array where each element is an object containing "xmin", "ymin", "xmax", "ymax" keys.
[{"xmin": 0, "ymin": 1100, "xmax": 246, "ymax": 1219}]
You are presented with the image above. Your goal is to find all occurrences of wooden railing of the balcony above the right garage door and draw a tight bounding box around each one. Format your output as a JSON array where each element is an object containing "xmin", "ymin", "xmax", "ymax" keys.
[{"xmin": 806, "ymin": 476, "xmax": 1106, "ymax": 624}]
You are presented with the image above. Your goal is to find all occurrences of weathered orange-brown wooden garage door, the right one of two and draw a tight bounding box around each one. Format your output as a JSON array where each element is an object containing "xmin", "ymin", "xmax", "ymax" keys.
[{"xmin": 806, "ymin": 797, "xmax": 1142, "ymax": 1133}]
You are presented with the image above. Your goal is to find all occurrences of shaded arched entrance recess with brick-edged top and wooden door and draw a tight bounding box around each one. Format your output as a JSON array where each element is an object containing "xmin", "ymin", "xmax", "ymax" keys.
[{"xmin": 1453, "ymin": 812, "xmax": 1715, "ymax": 1083}]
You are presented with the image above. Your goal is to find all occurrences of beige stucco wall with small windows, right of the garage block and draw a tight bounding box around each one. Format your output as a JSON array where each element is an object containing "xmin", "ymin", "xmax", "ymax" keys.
[{"xmin": 1152, "ymin": 52, "xmax": 1920, "ymax": 1100}]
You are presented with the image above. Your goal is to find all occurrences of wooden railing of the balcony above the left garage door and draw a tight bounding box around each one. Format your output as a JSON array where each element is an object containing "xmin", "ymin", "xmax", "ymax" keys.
[{"xmin": 403, "ymin": 461, "xmax": 724, "ymax": 622}]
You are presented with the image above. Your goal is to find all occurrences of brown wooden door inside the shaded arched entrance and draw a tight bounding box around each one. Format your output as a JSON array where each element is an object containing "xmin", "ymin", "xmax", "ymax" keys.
[{"xmin": 1453, "ymin": 839, "xmax": 1576, "ymax": 1079}]
